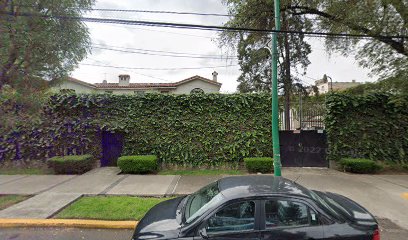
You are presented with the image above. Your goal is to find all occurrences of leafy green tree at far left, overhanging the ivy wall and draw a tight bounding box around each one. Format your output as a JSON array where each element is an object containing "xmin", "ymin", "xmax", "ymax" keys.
[{"xmin": 0, "ymin": 0, "xmax": 94, "ymax": 136}]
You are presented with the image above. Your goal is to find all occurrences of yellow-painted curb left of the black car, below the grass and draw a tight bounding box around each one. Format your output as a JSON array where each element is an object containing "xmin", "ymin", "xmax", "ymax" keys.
[{"xmin": 0, "ymin": 218, "xmax": 138, "ymax": 229}]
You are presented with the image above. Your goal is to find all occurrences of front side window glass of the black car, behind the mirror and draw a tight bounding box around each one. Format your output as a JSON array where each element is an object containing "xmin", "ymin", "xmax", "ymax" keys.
[{"xmin": 206, "ymin": 201, "xmax": 255, "ymax": 233}]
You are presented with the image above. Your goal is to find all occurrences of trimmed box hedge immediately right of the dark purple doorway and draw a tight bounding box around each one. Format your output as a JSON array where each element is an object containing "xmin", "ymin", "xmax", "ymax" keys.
[{"xmin": 118, "ymin": 155, "xmax": 158, "ymax": 173}]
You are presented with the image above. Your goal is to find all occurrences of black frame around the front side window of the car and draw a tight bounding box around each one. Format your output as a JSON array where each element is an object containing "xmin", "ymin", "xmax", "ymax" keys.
[{"xmin": 196, "ymin": 198, "xmax": 261, "ymax": 238}]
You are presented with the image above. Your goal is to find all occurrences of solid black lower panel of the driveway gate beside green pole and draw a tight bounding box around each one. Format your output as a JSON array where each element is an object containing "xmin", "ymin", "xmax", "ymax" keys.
[{"xmin": 279, "ymin": 130, "xmax": 329, "ymax": 167}]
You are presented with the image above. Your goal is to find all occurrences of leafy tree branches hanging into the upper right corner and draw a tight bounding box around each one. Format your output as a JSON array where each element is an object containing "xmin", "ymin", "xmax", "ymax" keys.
[{"xmin": 281, "ymin": 0, "xmax": 408, "ymax": 78}]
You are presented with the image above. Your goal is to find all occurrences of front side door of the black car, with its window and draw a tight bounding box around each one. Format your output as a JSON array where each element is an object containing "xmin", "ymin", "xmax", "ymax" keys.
[{"xmin": 194, "ymin": 200, "xmax": 260, "ymax": 240}]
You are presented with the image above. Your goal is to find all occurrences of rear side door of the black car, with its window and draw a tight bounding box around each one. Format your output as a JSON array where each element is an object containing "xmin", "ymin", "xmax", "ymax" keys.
[{"xmin": 260, "ymin": 198, "xmax": 324, "ymax": 240}]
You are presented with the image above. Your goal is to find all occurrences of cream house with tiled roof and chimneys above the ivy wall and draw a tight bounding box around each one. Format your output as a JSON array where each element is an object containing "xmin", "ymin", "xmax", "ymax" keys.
[{"xmin": 53, "ymin": 71, "xmax": 222, "ymax": 94}]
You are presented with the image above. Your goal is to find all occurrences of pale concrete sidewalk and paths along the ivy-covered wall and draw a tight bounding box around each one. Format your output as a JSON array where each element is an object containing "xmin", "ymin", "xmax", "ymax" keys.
[{"xmin": 0, "ymin": 168, "xmax": 408, "ymax": 229}]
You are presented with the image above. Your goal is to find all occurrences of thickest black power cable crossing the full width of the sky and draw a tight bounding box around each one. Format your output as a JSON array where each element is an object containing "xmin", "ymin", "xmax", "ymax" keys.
[{"xmin": 0, "ymin": 13, "xmax": 408, "ymax": 39}]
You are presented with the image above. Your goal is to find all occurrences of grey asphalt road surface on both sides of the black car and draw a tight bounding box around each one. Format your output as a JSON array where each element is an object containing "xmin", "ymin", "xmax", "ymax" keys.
[{"xmin": 0, "ymin": 219, "xmax": 408, "ymax": 240}]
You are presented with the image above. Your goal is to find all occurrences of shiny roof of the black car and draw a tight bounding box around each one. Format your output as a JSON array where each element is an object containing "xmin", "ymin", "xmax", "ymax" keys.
[{"xmin": 218, "ymin": 175, "xmax": 310, "ymax": 200}]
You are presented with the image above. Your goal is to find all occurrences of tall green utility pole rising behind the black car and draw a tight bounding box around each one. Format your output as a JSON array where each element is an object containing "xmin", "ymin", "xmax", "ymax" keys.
[{"xmin": 272, "ymin": 0, "xmax": 282, "ymax": 176}]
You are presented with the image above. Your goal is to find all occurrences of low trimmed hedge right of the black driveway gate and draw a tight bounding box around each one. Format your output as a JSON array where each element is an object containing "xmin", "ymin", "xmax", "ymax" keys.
[{"xmin": 340, "ymin": 158, "xmax": 382, "ymax": 173}]
